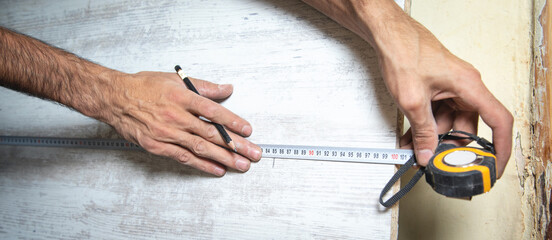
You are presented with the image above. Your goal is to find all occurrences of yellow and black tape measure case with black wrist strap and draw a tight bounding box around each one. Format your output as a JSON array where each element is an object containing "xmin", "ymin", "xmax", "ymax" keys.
[{"xmin": 379, "ymin": 131, "xmax": 496, "ymax": 207}]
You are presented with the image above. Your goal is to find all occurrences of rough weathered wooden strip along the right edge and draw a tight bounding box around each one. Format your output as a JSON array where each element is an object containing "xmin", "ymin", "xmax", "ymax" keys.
[{"xmin": 532, "ymin": 0, "xmax": 552, "ymax": 239}]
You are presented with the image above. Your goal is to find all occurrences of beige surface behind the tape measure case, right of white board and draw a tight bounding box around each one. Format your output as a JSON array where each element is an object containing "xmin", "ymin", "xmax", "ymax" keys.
[{"xmin": 399, "ymin": 0, "xmax": 533, "ymax": 239}]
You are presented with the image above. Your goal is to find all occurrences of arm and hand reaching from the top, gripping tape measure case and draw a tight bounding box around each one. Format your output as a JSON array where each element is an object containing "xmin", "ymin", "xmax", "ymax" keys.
[{"xmin": 303, "ymin": 0, "xmax": 513, "ymax": 176}]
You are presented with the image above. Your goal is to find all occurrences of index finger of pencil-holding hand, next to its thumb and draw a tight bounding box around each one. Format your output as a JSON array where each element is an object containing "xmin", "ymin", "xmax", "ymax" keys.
[{"xmin": 187, "ymin": 95, "xmax": 252, "ymax": 137}]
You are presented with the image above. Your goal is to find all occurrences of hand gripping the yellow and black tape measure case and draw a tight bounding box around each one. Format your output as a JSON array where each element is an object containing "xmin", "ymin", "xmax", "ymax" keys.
[{"xmin": 376, "ymin": 15, "xmax": 513, "ymax": 177}]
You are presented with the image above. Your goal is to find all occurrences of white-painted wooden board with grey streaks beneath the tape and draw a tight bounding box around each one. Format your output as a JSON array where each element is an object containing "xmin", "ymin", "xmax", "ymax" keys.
[{"xmin": 0, "ymin": 0, "xmax": 404, "ymax": 239}]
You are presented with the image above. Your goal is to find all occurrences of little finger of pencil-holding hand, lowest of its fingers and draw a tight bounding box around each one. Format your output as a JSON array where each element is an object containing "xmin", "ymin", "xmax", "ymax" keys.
[{"xmin": 139, "ymin": 139, "xmax": 226, "ymax": 177}]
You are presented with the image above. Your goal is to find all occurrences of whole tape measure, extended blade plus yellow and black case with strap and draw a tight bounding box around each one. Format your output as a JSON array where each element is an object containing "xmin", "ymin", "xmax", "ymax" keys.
[{"xmin": 0, "ymin": 131, "xmax": 496, "ymax": 207}]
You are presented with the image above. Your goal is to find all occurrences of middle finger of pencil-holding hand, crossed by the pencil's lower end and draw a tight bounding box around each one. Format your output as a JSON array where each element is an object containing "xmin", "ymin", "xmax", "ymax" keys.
[{"xmin": 186, "ymin": 115, "xmax": 261, "ymax": 161}]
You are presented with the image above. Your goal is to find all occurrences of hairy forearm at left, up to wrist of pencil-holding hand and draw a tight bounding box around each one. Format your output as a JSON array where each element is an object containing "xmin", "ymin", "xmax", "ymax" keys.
[{"xmin": 0, "ymin": 27, "xmax": 122, "ymax": 120}]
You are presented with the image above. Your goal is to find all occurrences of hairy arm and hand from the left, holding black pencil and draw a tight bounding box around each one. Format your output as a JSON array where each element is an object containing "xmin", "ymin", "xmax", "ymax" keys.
[{"xmin": 0, "ymin": 27, "xmax": 261, "ymax": 176}]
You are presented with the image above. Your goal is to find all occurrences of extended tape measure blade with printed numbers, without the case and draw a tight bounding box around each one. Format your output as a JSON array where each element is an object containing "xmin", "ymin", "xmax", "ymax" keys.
[{"xmin": 0, "ymin": 136, "xmax": 413, "ymax": 164}]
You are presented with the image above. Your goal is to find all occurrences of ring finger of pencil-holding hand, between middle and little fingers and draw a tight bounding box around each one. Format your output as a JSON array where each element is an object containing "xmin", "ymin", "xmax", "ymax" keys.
[{"xmin": 174, "ymin": 132, "xmax": 251, "ymax": 172}]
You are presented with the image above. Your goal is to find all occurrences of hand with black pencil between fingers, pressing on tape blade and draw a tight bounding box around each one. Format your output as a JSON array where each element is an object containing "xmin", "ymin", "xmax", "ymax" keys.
[{"xmin": 102, "ymin": 72, "xmax": 261, "ymax": 176}]
